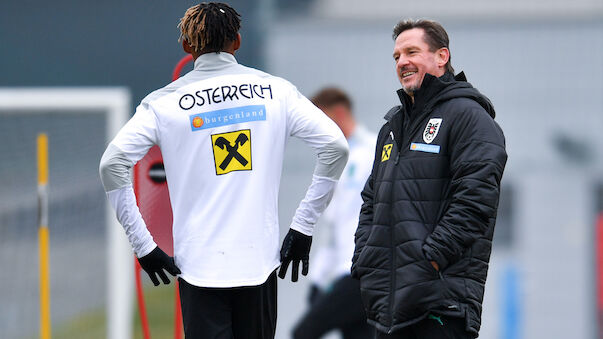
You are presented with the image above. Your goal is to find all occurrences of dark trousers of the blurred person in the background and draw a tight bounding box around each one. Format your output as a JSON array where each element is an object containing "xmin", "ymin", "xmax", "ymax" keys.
[{"xmin": 293, "ymin": 276, "xmax": 373, "ymax": 339}]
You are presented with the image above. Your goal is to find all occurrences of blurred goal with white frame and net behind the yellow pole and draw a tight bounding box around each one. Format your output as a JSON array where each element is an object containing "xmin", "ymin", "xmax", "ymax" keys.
[{"xmin": 0, "ymin": 88, "xmax": 133, "ymax": 338}]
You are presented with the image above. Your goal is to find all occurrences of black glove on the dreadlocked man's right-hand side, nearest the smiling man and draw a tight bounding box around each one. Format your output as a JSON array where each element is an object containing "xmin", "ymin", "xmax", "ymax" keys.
[{"xmin": 278, "ymin": 229, "xmax": 312, "ymax": 282}]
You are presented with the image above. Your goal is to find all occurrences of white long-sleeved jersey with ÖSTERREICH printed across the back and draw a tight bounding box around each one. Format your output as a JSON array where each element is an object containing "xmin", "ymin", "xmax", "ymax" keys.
[{"xmin": 100, "ymin": 53, "xmax": 348, "ymax": 287}]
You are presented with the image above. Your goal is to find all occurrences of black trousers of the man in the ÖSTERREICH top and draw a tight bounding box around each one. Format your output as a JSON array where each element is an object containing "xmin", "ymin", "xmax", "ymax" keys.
[{"xmin": 178, "ymin": 271, "xmax": 276, "ymax": 339}]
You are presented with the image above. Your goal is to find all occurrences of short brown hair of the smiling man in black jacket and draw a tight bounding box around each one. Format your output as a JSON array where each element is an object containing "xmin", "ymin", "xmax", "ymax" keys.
[{"xmin": 393, "ymin": 19, "xmax": 454, "ymax": 74}]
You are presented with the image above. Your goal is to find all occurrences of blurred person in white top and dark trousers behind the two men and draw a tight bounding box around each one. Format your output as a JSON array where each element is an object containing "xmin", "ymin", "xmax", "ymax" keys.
[{"xmin": 293, "ymin": 87, "xmax": 377, "ymax": 339}]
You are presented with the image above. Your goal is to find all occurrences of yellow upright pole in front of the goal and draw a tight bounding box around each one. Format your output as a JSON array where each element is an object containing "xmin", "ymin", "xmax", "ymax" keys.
[{"xmin": 38, "ymin": 133, "xmax": 51, "ymax": 339}]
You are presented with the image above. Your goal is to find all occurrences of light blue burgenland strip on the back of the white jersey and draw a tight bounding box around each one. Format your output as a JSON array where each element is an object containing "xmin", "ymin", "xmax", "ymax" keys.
[{"xmin": 189, "ymin": 105, "xmax": 266, "ymax": 132}]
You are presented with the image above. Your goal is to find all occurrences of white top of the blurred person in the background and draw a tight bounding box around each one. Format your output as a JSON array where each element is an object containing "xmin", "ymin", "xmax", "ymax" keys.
[{"xmin": 310, "ymin": 125, "xmax": 377, "ymax": 288}]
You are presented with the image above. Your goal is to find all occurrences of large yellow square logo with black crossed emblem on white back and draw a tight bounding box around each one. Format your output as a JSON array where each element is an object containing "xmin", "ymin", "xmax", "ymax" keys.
[{"xmin": 211, "ymin": 129, "xmax": 251, "ymax": 175}]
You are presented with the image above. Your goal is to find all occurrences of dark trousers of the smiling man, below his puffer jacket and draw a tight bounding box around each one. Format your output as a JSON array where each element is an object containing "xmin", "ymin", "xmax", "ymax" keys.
[{"xmin": 375, "ymin": 314, "xmax": 474, "ymax": 339}]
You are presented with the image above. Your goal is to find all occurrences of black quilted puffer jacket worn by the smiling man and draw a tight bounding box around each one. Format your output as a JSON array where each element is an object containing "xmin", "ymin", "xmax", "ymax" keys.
[{"xmin": 352, "ymin": 73, "xmax": 507, "ymax": 336}]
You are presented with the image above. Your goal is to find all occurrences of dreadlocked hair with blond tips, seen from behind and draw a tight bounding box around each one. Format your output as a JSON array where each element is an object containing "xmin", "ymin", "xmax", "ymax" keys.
[{"xmin": 178, "ymin": 2, "xmax": 241, "ymax": 53}]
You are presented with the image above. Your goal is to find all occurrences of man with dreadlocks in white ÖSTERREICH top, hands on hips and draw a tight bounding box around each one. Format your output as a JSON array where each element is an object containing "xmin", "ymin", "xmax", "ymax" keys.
[{"xmin": 100, "ymin": 3, "xmax": 348, "ymax": 339}]
